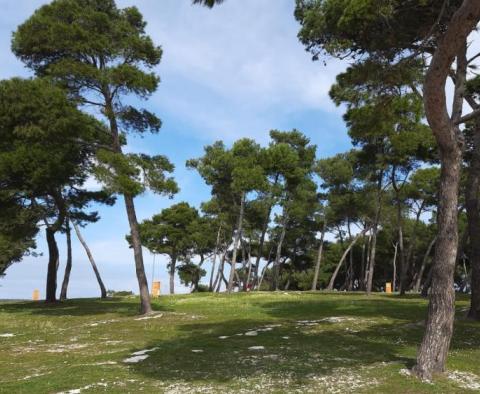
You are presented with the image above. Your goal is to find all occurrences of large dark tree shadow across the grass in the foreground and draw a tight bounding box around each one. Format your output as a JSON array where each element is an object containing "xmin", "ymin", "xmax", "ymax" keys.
[{"xmin": 128, "ymin": 320, "xmax": 419, "ymax": 385}]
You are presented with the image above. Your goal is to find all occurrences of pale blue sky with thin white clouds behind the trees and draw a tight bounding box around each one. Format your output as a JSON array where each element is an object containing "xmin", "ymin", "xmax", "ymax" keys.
[{"xmin": 0, "ymin": 0, "xmax": 350, "ymax": 299}]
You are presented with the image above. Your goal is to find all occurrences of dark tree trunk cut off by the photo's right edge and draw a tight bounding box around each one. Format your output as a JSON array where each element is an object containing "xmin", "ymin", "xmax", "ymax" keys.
[{"xmin": 465, "ymin": 120, "xmax": 480, "ymax": 320}]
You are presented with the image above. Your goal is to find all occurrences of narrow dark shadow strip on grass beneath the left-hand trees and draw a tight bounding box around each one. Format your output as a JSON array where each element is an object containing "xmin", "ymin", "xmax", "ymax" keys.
[{"xmin": 0, "ymin": 297, "xmax": 172, "ymax": 317}]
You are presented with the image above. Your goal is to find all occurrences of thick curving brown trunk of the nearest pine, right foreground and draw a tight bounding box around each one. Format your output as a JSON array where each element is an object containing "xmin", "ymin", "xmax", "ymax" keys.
[{"xmin": 414, "ymin": 6, "xmax": 480, "ymax": 379}]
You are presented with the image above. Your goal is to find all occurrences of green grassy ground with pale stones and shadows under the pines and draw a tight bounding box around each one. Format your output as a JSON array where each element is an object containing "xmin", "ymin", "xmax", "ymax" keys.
[{"xmin": 0, "ymin": 292, "xmax": 480, "ymax": 393}]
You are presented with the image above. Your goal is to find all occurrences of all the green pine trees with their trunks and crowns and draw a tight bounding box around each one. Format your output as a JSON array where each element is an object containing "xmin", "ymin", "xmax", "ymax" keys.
[{"xmin": 0, "ymin": 0, "xmax": 480, "ymax": 379}]
